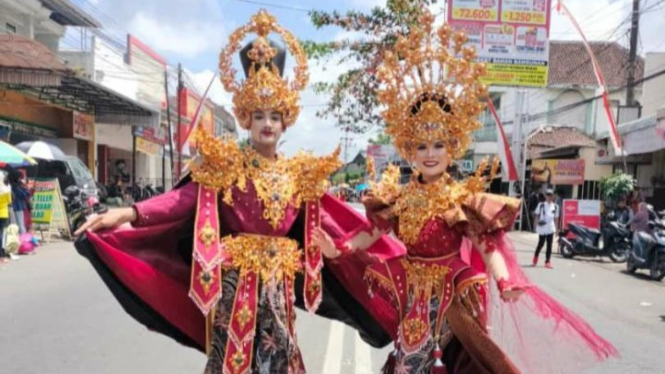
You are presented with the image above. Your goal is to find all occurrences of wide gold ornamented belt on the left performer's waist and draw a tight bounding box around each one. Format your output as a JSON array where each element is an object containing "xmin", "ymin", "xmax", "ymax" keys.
[{"xmin": 221, "ymin": 234, "xmax": 302, "ymax": 281}]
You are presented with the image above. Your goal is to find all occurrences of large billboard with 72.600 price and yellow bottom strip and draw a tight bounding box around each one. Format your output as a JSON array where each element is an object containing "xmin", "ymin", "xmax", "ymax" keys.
[{"xmin": 448, "ymin": 0, "xmax": 551, "ymax": 87}]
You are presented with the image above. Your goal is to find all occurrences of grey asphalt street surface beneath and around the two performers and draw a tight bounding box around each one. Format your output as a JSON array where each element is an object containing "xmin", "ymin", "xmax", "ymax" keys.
[{"xmin": 0, "ymin": 226, "xmax": 665, "ymax": 374}]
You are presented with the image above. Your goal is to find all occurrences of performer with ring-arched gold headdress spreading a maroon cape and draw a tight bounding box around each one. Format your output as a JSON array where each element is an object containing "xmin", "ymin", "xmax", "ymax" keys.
[{"xmin": 77, "ymin": 11, "xmax": 403, "ymax": 374}]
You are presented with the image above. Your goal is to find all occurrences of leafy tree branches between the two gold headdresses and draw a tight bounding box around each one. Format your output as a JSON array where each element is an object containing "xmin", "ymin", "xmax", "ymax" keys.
[{"xmin": 303, "ymin": 0, "xmax": 437, "ymax": 133}]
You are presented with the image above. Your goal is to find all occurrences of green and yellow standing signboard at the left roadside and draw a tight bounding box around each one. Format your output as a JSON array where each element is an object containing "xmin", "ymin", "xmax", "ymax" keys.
[{"xmin": 30, "ymin": 179, "xmax": 71, "ymax": 242}]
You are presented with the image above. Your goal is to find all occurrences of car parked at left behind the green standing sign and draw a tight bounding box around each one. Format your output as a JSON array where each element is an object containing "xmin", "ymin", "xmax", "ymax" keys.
[{"xmin": 24, "ymin": 156, "xmax": 98, "ymax": 197}]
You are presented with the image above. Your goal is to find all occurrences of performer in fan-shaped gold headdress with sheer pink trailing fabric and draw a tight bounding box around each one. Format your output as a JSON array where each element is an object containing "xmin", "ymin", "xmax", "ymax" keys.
[{"xmin": 315, "ymin": 12, "xmax": 617, "ymax": 374}]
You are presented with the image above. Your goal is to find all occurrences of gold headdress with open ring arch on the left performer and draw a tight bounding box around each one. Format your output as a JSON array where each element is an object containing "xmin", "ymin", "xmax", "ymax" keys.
[{"xmin": 219, "ymin": 10, "xmax": 309, "ymax": 129}]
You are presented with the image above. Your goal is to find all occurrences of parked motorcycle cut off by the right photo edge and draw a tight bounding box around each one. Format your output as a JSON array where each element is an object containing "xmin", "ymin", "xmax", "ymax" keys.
[{"xmin": 626, "ymin": 211, "xmax": 665, "ymax": 281}]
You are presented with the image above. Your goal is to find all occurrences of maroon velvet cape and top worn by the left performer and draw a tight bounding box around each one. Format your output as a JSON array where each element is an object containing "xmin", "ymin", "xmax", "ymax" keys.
[{"xmin": 77, "ymin": 182, "xmax": 403, "ymax": 372}]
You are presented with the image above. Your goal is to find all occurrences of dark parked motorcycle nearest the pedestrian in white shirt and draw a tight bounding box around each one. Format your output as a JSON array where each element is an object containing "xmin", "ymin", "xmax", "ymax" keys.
[{"xmin": 559, "ymin": 216, "xmax": 632, "ymax": 262}]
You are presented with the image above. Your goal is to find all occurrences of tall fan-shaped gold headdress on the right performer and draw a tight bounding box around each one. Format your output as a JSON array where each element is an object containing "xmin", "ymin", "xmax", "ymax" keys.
[{"xmin": 378, "ymin": 10, "xmax": 487, "ymax": 158}]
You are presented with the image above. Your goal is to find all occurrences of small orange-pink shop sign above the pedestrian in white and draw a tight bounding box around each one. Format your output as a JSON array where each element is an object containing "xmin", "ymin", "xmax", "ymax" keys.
[{"xmin": 531, "ymin": 159, "xmax": 584, "ymax": 186}]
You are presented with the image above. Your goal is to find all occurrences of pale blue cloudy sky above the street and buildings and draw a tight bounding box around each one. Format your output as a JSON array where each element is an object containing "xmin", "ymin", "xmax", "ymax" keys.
[{"xmin": 68, "ymin": 0, "xmax": 665, "ymax": 158}]
